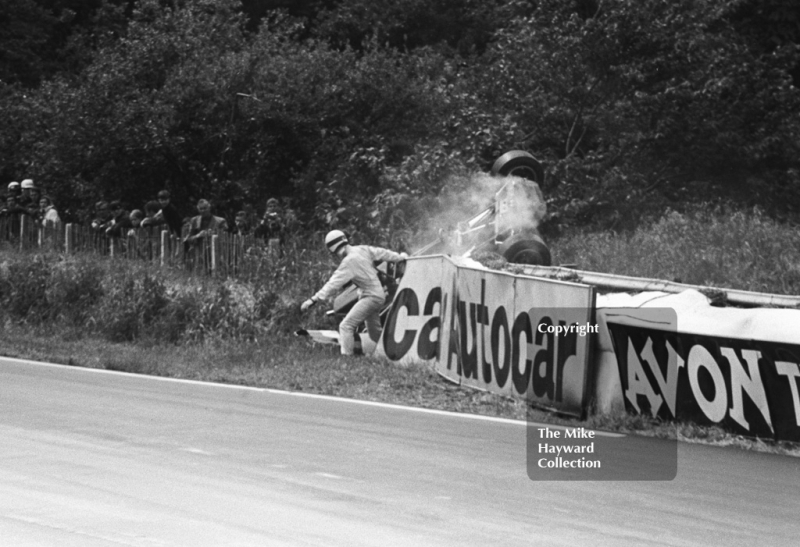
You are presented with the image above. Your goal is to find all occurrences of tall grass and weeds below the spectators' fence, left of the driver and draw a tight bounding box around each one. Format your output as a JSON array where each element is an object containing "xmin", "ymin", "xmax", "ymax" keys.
[{"xmin": 0, "ymin": 238, "xmax": 334, "ymax": 343}]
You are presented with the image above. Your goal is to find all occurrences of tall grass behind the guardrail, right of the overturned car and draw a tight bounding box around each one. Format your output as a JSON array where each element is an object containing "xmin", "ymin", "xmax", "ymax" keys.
[{"xmin": 550, "ymin": 208, "xmax": 800, "ymax": 294}]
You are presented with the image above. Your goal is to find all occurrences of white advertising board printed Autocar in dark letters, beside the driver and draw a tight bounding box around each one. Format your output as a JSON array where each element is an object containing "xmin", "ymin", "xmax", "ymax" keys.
[{"xmin": 378, "ymin": 256, "xmax": 596, "ymax": 415}]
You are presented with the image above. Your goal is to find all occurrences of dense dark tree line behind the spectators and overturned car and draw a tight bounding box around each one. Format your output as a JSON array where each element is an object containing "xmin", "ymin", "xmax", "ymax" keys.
[{"xmin": 0, "ymin": 0, "xmax": 800, "ymax": 238}]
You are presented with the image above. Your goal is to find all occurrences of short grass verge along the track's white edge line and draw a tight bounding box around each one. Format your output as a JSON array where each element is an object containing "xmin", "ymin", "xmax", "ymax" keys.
[{"xmin": 0, "ymin": 323, "xmax": 800, "ymax": 457}]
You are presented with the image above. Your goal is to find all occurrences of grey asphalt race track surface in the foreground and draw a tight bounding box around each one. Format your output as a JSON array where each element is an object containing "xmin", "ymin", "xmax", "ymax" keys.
[{"xmin": 0, "ymin": 358, "xmax": 800, "ymax": 547}]
